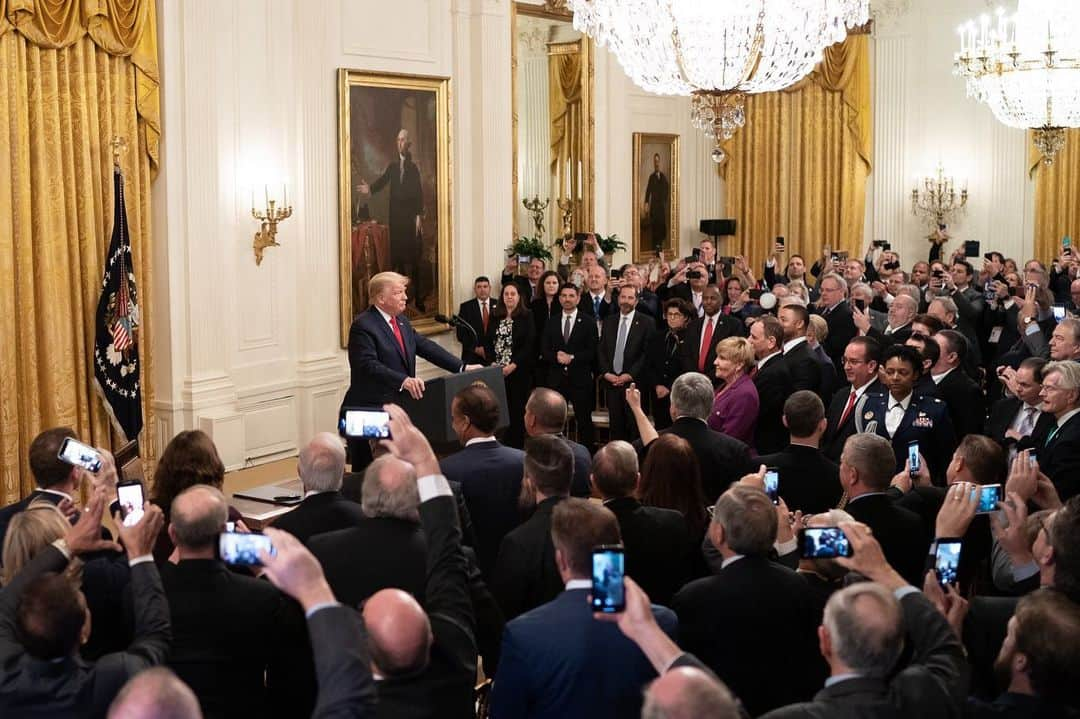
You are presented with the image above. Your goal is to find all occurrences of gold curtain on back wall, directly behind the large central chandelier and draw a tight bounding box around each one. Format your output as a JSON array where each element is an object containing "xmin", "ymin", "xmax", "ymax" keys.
[{"xmin": 720, "ymin": 35, "xmax": 873, "ymax": 268}]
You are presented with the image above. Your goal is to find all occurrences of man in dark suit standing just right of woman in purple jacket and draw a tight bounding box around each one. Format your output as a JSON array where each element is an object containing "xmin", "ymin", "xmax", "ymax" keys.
[{"xmin": 750, "ymin": 315, "xmax": 794, "ymax": 455}]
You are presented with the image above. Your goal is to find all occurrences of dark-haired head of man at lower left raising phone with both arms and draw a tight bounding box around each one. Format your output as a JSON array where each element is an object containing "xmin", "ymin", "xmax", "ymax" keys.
[{"xmin": 15, "ymin": 572, "xmax": 86, "ymax": 660}]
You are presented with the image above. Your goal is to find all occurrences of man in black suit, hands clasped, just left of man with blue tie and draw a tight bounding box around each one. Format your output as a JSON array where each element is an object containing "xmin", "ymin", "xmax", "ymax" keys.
[{"xmin": 542, "ymin": 284, "xmax": 599, "ymax": 447}]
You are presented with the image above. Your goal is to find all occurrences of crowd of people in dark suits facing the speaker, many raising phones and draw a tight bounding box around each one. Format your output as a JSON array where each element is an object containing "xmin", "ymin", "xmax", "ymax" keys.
[{"xmin": 0, "ymin": 234, "xmax": 1080, "ymax": 719}]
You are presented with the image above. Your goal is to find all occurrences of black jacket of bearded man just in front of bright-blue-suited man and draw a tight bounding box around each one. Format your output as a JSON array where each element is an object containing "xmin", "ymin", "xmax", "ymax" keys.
[{"xmin": 491, "ymin": 497, "xmax": 566, "ymax": 620}]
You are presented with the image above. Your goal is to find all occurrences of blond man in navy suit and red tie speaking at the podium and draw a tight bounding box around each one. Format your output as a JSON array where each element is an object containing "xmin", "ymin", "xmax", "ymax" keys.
[{"xmin": 341, "ymin": 272, "xmax": 481, "ymax": 472}]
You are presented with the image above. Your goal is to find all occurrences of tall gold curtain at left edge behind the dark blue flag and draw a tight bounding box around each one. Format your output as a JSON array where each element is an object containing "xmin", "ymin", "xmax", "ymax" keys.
[{"xmin": 0, "ymin": 0, "xmax": 161, "ymax": 503}]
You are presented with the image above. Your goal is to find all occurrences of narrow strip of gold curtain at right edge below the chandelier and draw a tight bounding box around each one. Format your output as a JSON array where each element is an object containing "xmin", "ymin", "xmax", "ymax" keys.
[{"xmin": 1028, "ymin": 130, "xmax": 1080, "ymax": 262}]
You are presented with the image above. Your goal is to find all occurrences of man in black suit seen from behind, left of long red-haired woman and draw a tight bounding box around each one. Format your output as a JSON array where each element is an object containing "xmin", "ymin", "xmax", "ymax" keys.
[{"xmin": 591, "ymin": 440, "xmax": 700, "ymax": 606}]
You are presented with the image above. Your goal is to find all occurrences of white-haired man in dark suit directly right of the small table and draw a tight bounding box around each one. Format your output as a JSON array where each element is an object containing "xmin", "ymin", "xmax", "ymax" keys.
[{"xmin": 273, "ymin": 432, "xmax": 364, "ymax": 544}]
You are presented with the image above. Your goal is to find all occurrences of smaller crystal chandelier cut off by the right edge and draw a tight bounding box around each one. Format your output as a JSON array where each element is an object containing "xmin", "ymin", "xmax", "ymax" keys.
[{"xmin": 953, "ymin": 0, "xmax": 1080, "ymax": 165}]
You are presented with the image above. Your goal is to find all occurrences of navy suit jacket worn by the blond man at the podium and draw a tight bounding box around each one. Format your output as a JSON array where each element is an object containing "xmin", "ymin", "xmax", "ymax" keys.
[{"xmin": 342, "ymin": 307, "xmax": 461, "ymax": 407}]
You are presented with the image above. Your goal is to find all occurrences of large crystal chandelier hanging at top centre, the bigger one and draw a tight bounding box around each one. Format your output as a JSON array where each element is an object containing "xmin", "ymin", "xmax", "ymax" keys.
[{"xmin": 567, "ymin": 0, "xmax": 869, "ymax": 162}]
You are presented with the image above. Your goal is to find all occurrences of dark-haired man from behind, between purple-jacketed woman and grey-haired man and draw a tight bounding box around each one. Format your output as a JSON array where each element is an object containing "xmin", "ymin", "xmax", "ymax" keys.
[{"xmin": 757, "ymin": 390, "xmax": 843, "ymax": 515}]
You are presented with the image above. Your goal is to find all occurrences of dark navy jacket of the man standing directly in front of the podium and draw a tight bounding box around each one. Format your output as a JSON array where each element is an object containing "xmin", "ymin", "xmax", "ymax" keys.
[{"xmin": 438, "ymin": 439, "xmax": 525, "ymax": 576}]
